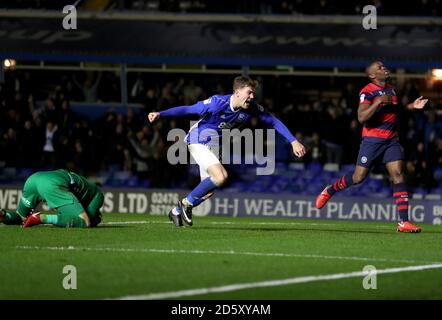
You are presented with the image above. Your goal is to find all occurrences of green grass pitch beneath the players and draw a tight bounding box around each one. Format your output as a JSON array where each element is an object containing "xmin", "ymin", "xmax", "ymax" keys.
[{"xmin": 0, "ymin": 214, "xmax": 442, "ymax": 300}]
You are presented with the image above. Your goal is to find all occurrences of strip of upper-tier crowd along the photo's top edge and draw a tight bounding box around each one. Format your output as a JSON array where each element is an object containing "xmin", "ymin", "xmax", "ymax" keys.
[{"xmin": 0, "ymin": 0, "xmax": 442, "ymax": 16}]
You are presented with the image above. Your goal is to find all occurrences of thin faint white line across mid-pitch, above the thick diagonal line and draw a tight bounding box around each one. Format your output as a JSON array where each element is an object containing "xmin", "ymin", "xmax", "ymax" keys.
[{"xmin": 15, "ymin": 246, "xmax": 439, "ymax": 264}]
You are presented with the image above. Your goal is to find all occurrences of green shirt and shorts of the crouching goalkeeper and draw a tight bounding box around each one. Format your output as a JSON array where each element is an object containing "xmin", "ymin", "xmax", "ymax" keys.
[{"xmin": 18, "ymin": 169, "xmax": 101, "ymax": 216}]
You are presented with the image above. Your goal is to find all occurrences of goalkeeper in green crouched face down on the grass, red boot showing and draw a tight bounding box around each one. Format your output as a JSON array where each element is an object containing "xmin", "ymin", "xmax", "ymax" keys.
[{"xmin": 0, "ymin": 169, "xmax": 104, "ymax": 228}]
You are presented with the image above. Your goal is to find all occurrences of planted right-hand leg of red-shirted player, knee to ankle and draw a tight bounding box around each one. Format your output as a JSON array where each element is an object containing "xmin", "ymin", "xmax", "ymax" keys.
[{"xmin": 385, "ymin": 160, "xmax": 408, "ymax": 221}]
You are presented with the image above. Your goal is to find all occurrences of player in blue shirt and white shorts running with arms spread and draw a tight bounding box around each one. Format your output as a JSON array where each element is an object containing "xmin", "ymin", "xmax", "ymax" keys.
[{"xmin": 148, "ymin": 76, "xmax": 305, "ymax": 227}]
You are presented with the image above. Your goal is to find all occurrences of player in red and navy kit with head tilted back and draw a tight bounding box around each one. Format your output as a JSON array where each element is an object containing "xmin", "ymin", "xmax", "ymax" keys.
[{"xmin": 316, "ymin": 61, "xmax": 428, "ymax": 233}]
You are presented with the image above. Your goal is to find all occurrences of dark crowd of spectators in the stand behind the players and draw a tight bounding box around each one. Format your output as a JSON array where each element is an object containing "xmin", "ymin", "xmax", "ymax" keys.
[{"xmin": 0, "ymin": 70, "xmax": 442, "ymax": 192}]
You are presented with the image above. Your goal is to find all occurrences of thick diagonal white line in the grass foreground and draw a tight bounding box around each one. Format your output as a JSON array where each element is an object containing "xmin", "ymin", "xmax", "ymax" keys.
[{"xmin": 117, "ymin": 263, "xmax": 442, "ymax": 300}]
